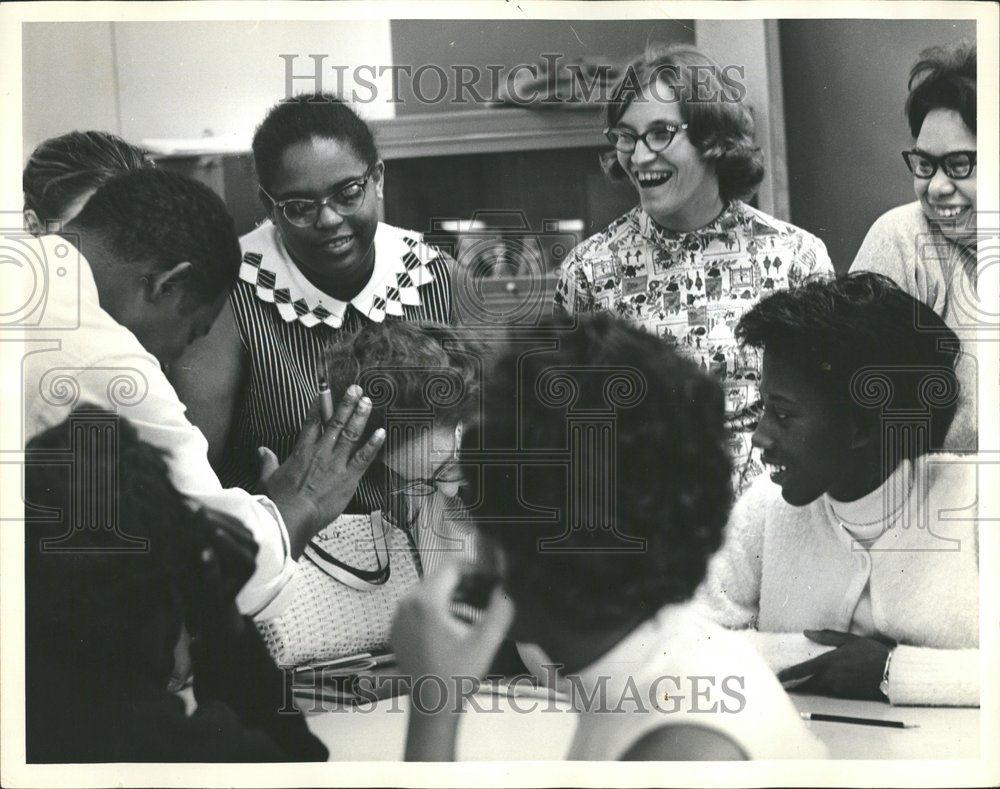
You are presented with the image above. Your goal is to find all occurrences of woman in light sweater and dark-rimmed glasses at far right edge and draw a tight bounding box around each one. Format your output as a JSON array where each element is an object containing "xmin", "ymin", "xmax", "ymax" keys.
[{"xmin": 851, "ymin": 44, "xmax": 983, "ymax": 451}]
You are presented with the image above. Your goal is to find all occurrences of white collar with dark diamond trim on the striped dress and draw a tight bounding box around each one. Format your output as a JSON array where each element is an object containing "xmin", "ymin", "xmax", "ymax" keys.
[{"xmin": 240, "ymin": 221, "xmax": 440, "ymax": 329}]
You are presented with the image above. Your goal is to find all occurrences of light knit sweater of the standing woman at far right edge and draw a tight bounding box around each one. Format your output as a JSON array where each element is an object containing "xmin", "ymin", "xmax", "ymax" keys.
[{"xmin": 851, "ymin": 202, "xmax": 976, "ymax": 452}]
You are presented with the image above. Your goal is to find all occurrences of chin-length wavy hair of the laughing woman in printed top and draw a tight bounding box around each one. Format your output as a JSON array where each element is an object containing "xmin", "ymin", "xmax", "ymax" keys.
[{"xmin": 601, "ymin": 44, "xmax": 764, "ymax": 201}]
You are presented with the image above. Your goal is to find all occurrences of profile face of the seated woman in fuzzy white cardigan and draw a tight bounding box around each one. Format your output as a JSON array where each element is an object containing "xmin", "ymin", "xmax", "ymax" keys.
[{"xmin": 753, "ymin": 351, "xmax": 878, "ymax": 507}]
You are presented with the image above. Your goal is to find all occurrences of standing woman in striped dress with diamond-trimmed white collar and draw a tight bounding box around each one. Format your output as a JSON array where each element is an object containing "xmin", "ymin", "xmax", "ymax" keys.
[{"xmin": 172, "ymin": 94, "xmax": 451, "ymax": 513}]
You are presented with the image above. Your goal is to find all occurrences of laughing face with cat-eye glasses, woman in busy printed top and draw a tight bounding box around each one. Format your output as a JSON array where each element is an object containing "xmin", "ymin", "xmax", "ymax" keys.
[{"xmin": 616, "ymin": 82, "xmax": 723, "ymax": 231}]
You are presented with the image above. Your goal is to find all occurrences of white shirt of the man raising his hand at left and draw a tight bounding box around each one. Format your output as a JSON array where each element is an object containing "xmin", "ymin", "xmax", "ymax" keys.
[{"xmin": 21, "ymin": 231, "xmax": 295, "ymax": 618}]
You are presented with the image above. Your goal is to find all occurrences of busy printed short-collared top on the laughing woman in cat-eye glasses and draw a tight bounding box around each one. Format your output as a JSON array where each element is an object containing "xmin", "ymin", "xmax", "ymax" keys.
[{"xmin": 555, "ymin": 201, "xmax": 834, "ymax": 492}]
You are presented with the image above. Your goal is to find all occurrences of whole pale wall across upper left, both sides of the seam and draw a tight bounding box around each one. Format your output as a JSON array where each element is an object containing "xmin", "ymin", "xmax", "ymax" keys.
[{"xmin": 23, "ymin": 20, "xmax": 394, "ymax": 156}]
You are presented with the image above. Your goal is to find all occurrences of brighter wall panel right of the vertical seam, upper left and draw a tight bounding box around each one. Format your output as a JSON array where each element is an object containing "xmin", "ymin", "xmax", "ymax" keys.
[{"xmin": 115, "ymin": 21, "xmax": 393, "ymax": 144}]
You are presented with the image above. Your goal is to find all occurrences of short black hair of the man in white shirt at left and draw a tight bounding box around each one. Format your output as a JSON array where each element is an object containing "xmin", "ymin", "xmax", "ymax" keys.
[{"xmin": 70, "ymin": 169, "xmax": 240, "ymax": 303}]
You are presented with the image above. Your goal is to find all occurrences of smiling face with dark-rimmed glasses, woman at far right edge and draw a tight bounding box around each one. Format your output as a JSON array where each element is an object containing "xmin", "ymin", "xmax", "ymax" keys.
[{"xmin": 913, "ymin": 109, "xmax": 976, "ymax": 241}]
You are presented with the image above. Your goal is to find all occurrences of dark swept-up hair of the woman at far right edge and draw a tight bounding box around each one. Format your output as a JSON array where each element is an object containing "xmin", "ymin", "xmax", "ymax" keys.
[{"xmin": 906, "ymin": 41, "xmax": 976, "ymax": 138}]
